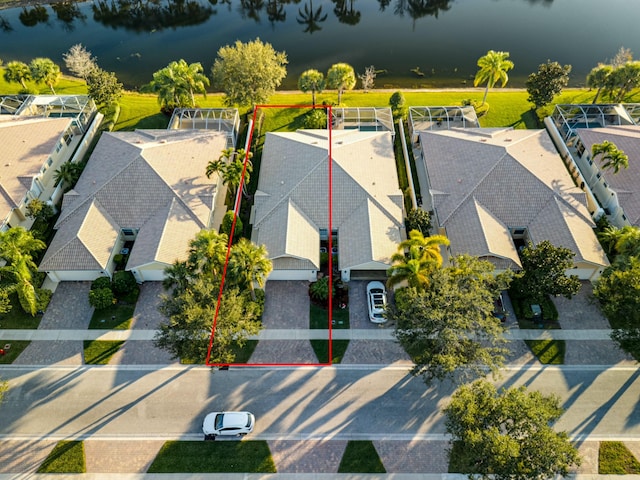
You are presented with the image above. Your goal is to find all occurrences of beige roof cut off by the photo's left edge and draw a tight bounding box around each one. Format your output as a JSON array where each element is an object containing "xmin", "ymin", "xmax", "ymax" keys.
[{"xmin": 0, "ymin": 115, "xmax": 72, "ymax": 218}]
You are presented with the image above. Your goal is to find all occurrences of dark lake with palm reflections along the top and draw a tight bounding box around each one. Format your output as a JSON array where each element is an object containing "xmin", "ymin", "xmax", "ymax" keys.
[{"xmin": 0, "ymin": 0, "xmax": 640, "ymax": 89}]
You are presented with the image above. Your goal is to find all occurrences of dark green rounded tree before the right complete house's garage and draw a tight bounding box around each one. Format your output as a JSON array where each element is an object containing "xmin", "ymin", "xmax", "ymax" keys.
[{"xmin": 513, "ymin": 240, "xmax": 580, "ymax": 302}]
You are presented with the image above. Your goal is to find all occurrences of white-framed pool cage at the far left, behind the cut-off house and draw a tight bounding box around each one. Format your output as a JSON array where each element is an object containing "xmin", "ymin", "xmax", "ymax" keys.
[{"xmin": 0, "ymin": 95, "xmax": 96, "ymax": 132}]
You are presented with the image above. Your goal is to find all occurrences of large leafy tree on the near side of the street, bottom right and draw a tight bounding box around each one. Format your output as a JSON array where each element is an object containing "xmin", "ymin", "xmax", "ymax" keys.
[{"xmin": 444, "ymin": 380, "xmax": 580, "ymax": 480}]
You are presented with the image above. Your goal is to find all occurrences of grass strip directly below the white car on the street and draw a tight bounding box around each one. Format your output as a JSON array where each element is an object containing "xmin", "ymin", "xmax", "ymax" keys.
[{"xmin": 148, "ymin": 440, "xmax": 276, "ymax": 473}]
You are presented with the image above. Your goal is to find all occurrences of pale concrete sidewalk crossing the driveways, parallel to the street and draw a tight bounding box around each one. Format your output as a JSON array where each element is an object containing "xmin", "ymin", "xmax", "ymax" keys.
[{"xmin": 0, "ymin": 328, "xmax": 611, "ymax": 347}]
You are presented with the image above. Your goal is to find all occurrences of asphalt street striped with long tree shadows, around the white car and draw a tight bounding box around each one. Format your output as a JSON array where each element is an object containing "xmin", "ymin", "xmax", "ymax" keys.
[{"xmin": 0, "ymin": 365, "xmax": 640, "ymax": 440}]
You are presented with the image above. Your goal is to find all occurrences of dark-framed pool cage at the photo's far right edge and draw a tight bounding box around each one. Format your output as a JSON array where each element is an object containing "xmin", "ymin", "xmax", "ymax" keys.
[{"xmin": 551, "ymin": 103, "xmax": 640, "ymax": 145}]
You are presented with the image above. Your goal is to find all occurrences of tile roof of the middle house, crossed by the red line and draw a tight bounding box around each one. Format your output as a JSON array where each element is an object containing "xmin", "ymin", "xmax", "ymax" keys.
[{"xmin": 254, "ymin": 130, "xmax": 403, "ymax": 269}]
